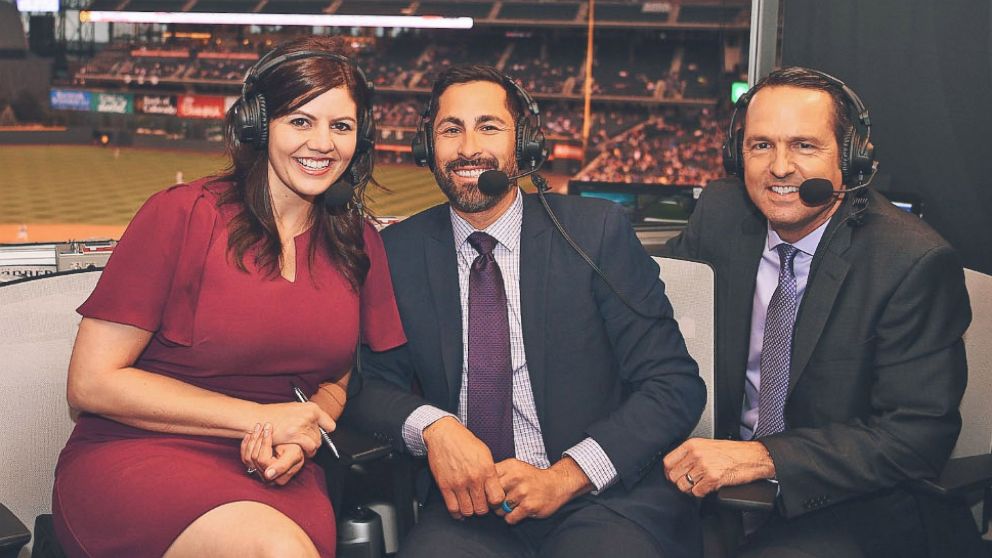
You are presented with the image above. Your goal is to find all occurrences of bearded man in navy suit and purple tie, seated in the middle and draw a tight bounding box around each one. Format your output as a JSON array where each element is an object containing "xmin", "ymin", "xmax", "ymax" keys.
[{"xmin": 345, "ymin": 66, "xmax": 705, "ymax": 557}]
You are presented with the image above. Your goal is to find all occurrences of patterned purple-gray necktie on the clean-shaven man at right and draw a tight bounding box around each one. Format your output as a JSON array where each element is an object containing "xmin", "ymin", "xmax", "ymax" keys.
[{"xmin": 754, "ymin": 243, "xmax": 799, "ymax": 438}]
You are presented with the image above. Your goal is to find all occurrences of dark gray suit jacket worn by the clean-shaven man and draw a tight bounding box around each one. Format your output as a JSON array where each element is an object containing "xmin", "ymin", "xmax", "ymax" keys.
[{"xmin": 667, "ymin": 179, "xmax": 971, "ymax": 517}]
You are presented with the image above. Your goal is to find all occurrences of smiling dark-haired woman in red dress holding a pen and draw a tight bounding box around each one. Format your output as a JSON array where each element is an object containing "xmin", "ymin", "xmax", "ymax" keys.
[{"xmin": 52, "ymin": 37, "xmax": 405, "ymax": 558}]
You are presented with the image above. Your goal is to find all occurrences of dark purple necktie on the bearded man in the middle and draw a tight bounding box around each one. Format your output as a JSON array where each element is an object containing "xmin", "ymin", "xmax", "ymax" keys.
[{"xmin": 466, "ymin": 232, "xmax": 515, "ymax": 461}]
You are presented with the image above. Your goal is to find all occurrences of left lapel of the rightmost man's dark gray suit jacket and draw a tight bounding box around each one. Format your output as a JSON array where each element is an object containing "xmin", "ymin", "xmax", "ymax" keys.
[{"xmin": 717, "ymin": 215, "xmax": 768, "ymax": 436}]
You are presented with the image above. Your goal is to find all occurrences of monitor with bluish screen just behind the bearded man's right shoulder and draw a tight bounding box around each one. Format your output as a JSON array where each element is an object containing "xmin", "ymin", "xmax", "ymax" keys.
[{"xmin": 568, "ymin": 180, "xmax": 701, "ymax": 228}]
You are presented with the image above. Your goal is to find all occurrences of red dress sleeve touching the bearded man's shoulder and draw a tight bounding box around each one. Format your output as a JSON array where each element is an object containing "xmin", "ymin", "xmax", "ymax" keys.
[{"xmin": 361, "ymin": 223, "xmax": 406, "ymax": 351}]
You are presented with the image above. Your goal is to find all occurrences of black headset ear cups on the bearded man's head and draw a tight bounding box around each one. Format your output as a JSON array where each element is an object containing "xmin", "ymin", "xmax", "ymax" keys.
[{"xmin": 410, "ymin": 75, "xmax": 548, "ymax": 171}]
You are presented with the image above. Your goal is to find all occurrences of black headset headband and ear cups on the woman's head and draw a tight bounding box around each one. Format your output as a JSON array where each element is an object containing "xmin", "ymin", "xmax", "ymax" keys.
[{"xmin": 231, "ymin": 50, "xmax": 375, "ymax": 156}]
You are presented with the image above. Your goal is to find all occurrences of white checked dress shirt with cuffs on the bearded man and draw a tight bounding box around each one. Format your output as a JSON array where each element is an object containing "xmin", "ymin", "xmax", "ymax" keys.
[{"xmin": 403, "ymin": 190, "xmax": 617, "ymax": 492}]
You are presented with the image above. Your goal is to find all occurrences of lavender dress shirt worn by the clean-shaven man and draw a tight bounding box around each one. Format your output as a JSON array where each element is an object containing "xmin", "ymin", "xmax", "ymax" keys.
[{"xmin": 741, "ymin": 220, "xmax": 830, "ymax": 440}]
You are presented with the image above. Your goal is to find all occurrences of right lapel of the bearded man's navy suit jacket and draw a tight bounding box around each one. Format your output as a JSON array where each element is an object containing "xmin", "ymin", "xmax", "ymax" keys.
[{"xmin": 520, "ymin": 195, "xmax": 552, "ymax": 427}]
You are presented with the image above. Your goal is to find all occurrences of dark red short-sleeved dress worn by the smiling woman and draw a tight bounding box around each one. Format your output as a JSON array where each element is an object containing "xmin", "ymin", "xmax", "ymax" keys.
[{"xmin": 52, "ymin": 180, "xmax": 406, "ymax": 557}]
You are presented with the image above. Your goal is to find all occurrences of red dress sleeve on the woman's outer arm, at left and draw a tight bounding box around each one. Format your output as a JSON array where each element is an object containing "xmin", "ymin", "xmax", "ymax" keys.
[{"xmin": 77, "ymin": 187, "xmax": 192, "ymax": 332}]
